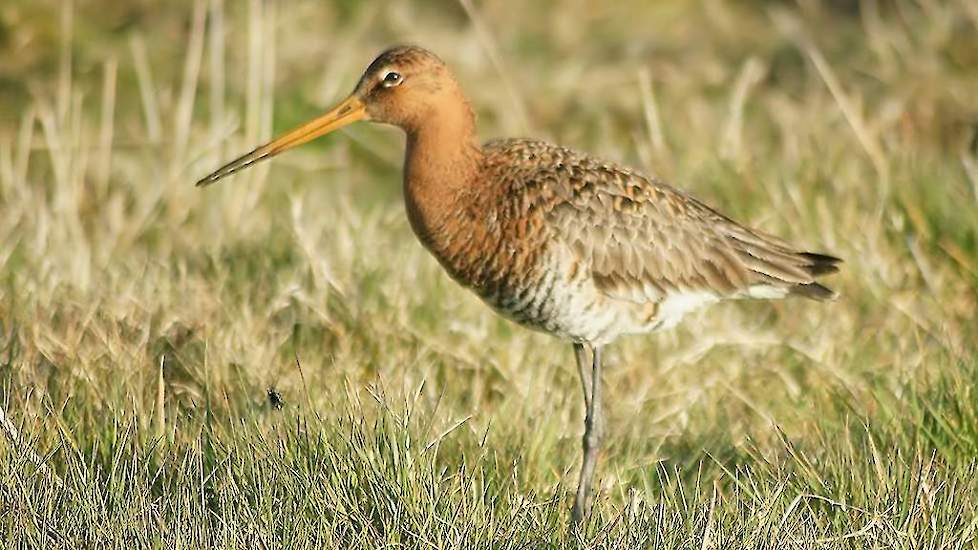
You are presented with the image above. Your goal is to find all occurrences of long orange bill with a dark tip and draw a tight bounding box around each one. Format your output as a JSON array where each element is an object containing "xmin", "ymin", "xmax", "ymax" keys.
[{"xmin": 197, "ymin": 95, "xmax": 367, "ymax": 187}]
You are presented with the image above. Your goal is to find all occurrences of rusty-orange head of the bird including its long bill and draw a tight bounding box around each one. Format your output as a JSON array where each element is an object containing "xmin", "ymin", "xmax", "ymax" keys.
[{"xmin": 197, "ymin": 46, "xmax": 464, "ymax": 186}]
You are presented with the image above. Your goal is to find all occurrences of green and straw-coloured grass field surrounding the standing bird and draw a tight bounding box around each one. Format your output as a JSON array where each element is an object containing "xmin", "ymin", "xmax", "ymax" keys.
[{"xmin": 0, "ymin": 0, "xmax": 978, "ymax": 549}]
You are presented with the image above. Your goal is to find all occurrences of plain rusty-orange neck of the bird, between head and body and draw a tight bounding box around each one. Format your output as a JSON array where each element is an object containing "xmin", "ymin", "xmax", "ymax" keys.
[{"xmin": 404, "ymin": 98, "xmax": 482, "ymax": 255}]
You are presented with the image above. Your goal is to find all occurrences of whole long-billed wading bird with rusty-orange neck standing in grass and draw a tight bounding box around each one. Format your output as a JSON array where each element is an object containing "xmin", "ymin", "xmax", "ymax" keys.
[{"xmin": 197, "ymin": 46, "xmax": 840, "ymax": 524}]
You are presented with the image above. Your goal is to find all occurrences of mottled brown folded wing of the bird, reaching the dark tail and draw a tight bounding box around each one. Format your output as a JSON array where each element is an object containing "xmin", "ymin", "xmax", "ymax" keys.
[{"xmin": 486, "ymin": 140, "xmax": 840, "ymax": 302}]
